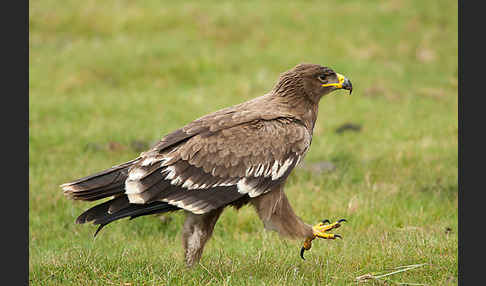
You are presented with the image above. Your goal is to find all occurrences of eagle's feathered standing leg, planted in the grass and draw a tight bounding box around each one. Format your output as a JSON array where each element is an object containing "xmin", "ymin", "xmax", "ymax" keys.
[{"xmin": 182, "ymin": 208, "xmax": 224, "ymax": 267}]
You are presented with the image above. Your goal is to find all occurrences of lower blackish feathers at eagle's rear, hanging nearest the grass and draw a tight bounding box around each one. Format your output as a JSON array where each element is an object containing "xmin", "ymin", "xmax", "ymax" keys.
[{"xmin": 76, "ymin": 195, "xmax": 180, "ymax": 236}]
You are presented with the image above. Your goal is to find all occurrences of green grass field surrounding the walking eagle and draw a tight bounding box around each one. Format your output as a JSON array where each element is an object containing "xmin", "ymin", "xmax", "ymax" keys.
[{"xmin": 29, "ymin": 0, "xmax": 458, "ymax": 285}]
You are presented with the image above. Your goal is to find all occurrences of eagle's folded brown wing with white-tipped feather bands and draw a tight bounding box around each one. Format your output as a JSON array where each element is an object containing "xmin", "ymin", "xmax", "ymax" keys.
[{"xmin": 125, "ymin": 109, "xmax": 311, "ymax": 213}]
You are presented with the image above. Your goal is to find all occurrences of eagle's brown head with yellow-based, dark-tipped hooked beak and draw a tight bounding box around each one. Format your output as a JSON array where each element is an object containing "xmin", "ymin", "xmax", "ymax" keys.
[{"xmin": 273, "ymin": 64, "xmax": 353, "ymax": 102}]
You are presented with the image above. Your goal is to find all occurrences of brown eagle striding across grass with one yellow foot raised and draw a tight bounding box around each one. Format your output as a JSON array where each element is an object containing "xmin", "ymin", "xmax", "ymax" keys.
[{"xmin": 60, "ymin": 63, "xmax": 352, "ymax": 267}]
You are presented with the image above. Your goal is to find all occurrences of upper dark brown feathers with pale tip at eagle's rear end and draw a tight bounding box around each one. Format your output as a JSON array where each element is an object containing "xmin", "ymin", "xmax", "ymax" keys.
[{"xmin": 61, "ymin": 158, "xmax": 140, "ymax": 201}]
